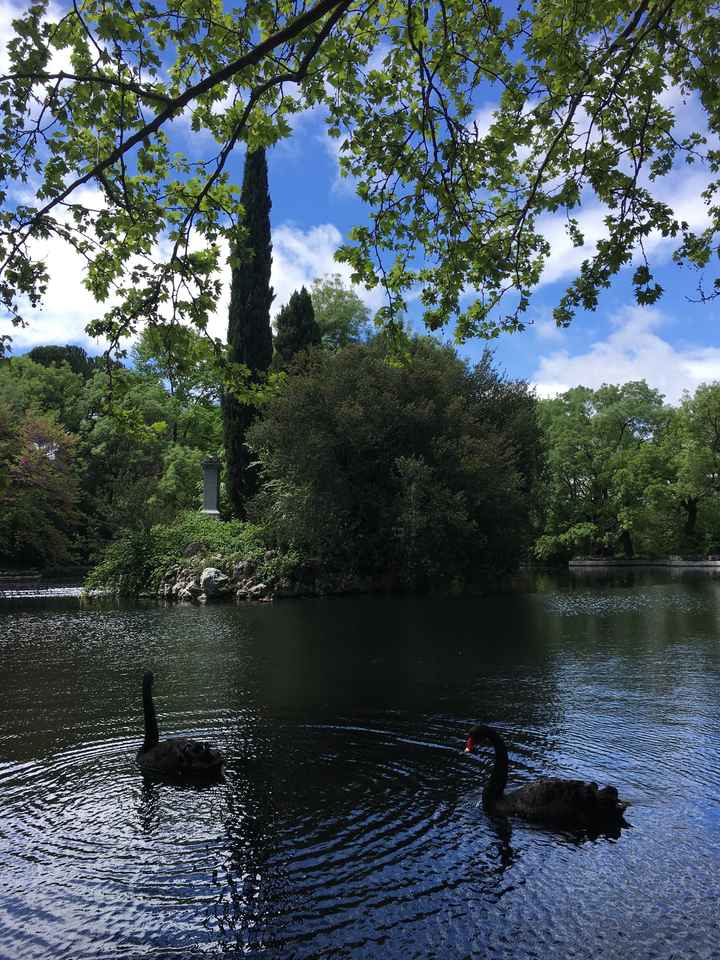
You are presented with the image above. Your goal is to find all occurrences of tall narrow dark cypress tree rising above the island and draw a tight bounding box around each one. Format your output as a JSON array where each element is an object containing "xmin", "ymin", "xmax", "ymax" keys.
[{"xmin": 223, "ymin": 147, "xmax": 273, "ymax": 517}]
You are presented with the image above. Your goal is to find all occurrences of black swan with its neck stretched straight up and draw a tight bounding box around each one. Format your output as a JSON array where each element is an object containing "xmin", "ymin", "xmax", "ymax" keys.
[{"xmin": 135, "ymin": 670, "xmax": 225, "ymax": 779}]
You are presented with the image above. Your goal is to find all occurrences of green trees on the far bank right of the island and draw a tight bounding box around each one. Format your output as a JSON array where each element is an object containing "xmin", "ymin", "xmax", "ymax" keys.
[{"xmin": 535, "ymin": 381, "xmax": 720, "ymax": 559}]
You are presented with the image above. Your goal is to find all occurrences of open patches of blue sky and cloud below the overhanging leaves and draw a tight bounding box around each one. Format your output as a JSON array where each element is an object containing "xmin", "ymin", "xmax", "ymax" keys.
[{"xmin": 0, "ymin": 0, "xmax": 720, "ymax": 402}]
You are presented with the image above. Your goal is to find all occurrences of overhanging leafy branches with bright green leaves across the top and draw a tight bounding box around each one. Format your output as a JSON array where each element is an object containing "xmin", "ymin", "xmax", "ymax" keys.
[{"xmin": 0, "ymin": 0, "xmax": 720, "ymax": 343}]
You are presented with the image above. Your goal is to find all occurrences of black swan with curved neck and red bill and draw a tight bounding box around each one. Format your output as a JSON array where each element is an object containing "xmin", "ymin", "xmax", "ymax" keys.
[{"xmin": 465, "ymin": 725, "xmax": 628, "ymax": 828}]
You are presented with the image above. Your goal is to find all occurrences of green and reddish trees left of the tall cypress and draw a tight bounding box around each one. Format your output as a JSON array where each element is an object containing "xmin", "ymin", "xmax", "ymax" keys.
[{"xmin": 0, "ymin": 336, "xmax": 222, "ymax": 566}]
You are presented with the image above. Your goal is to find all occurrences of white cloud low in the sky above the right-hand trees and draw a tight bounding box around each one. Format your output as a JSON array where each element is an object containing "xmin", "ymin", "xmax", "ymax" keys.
[{"xmin": 530, "ymin": 306, "xmax": 720, "ymax": 403}]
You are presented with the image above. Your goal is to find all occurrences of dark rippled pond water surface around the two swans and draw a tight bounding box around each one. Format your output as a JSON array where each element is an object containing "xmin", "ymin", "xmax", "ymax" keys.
[{"xmin": 0, "ymin": 574, "xmax": 720, "ymax": 960}]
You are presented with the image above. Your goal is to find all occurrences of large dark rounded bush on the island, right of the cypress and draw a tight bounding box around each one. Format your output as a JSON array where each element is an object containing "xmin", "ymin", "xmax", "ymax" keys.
[{"xmin": 248, "ymin": 339, "xmax": 540, "ymax": 587}]
